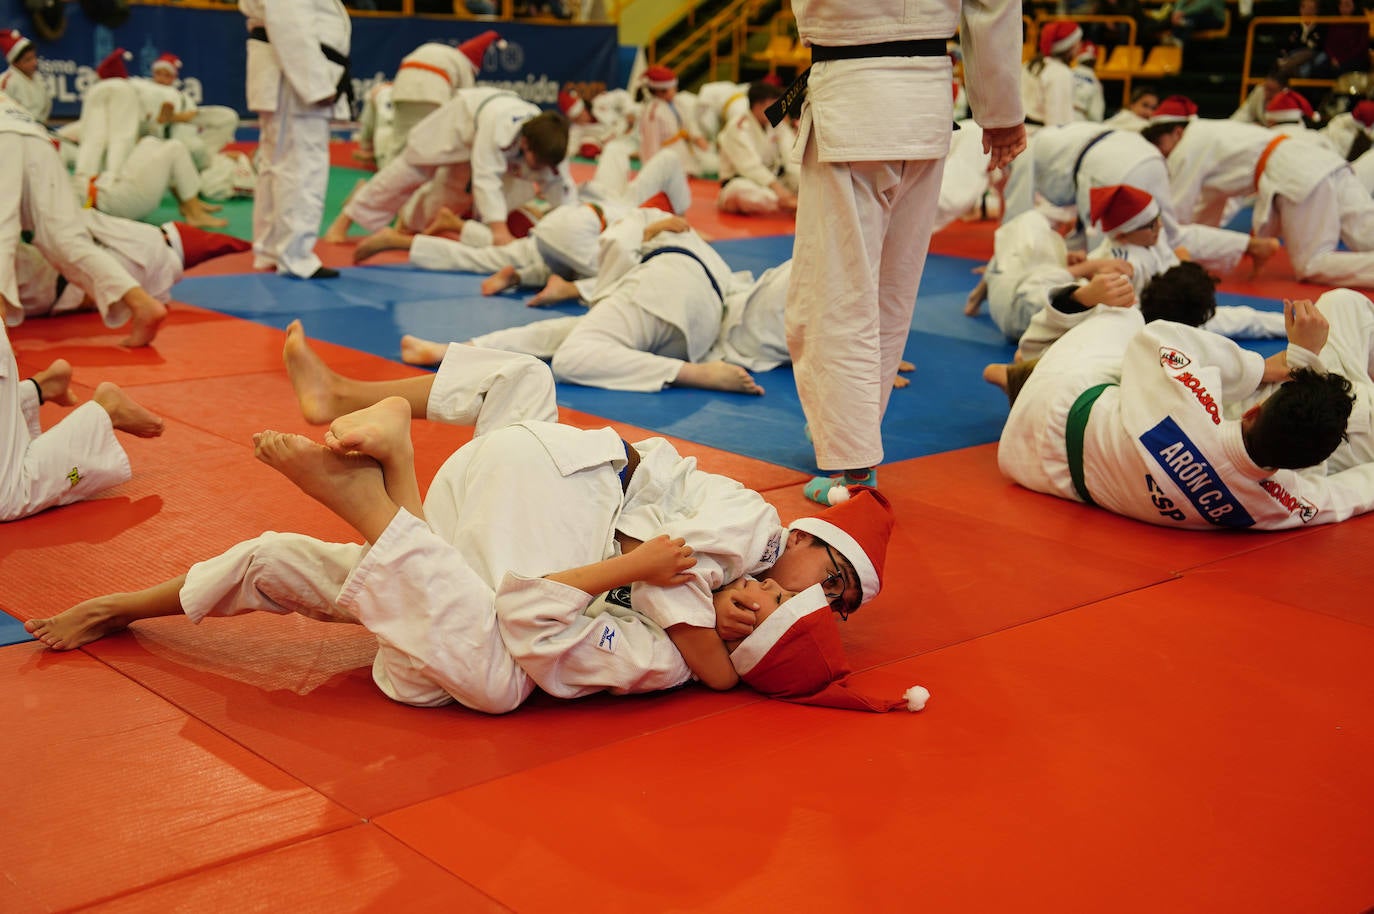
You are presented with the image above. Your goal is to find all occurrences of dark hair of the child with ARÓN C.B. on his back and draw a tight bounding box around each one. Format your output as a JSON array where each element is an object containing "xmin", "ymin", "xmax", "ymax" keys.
[{"xmin": 1245, "ymin": 368, "xmax": 1355, "ymax": 470}]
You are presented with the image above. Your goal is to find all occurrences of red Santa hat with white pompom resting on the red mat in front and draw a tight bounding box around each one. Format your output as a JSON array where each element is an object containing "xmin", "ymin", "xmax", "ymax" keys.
[{"xmin": 730, "ymin": 584, "xmax": 930, "ymax": 711}]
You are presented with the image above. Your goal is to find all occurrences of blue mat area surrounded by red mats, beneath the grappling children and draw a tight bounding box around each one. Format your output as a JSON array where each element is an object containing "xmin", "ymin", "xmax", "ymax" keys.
[{"xmin": 173, "ymin": 235, "xmax": 1281, "ymax": 473}]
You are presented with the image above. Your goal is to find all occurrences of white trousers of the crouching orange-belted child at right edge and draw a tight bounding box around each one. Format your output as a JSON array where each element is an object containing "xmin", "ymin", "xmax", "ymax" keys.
[{"xmin": 1274, "ymin": 168, "xmax": 1374, "ymax": 289}]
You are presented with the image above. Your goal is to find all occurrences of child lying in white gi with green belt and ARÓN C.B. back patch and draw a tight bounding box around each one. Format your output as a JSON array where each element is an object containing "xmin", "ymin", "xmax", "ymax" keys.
[{"xmin": 998, "ymin": 295, "xmax": 1374, "ymax": 529}]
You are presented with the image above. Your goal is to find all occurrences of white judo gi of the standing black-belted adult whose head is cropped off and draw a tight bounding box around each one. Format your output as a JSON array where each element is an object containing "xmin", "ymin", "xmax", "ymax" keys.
[{"xmin": 787, "ymin": 0, "xmax": 1022, "ymax": 470}]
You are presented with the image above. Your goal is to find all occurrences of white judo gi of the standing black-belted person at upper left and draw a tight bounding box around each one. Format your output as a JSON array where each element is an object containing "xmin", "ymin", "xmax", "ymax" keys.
[{"xmin": 239, "ymin": 0, "xmax": 353, "ymax": 276}]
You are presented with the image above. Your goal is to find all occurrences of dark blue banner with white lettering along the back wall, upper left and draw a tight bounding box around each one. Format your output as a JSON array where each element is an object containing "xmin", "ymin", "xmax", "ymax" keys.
[{"xmin": 0, "ymin": 0, "xmax": 620, "ymax": 118}]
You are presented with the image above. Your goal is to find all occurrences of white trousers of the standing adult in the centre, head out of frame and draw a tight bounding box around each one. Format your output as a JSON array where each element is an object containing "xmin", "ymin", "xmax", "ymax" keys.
[{"xmin": 787, "ymin": 140, "xmax": 944, "ymax": 470}]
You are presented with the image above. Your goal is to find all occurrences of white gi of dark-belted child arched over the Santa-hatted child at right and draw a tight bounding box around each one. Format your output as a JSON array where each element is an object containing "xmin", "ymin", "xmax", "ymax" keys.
[{"xmin": 1003, "ymin": 122, "xmax": 1250, "ymax": 274}]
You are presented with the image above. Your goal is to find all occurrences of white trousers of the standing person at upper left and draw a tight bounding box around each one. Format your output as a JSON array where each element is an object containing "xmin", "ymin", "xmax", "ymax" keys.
[{"xmin": 253, "ymin": 80, "xmax": 333, "ymax": 276}]
